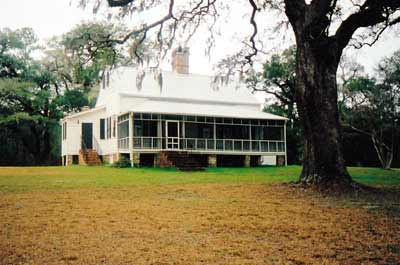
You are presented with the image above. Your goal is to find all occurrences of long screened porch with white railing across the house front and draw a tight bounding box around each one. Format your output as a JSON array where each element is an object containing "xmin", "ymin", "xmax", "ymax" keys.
[{"xmin": 118, "ymin": 113, "xmax": 286, "ymax": 155}]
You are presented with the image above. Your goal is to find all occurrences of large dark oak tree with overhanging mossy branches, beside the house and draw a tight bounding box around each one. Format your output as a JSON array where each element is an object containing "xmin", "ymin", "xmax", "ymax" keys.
[{"xmin": 80, "ymin": 0, "xmax": 400, "ymax": 188}]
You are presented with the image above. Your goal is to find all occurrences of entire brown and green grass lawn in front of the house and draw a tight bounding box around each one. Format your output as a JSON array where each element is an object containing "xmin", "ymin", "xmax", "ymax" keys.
[{"xmin": 0, "ymin": 166, "xmax": 400, "ymax": 264}]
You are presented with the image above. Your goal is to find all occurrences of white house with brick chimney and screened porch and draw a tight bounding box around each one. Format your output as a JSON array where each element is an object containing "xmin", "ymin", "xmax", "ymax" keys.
[{"xmin": 61, "ymin": 49, "xmax": 286, "ymax": 167}]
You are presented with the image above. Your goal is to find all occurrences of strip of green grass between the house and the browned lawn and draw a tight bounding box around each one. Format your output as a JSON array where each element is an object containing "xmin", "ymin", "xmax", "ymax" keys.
[{"xmin": 0, "ymin": 166, "xmax": 400, "ymax": 192}]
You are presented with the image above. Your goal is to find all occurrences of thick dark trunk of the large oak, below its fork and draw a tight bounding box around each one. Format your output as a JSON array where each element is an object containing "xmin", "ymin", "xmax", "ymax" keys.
[{"xmin": 296, "ymin": 39, "xmax": 352, "ymax": 189}]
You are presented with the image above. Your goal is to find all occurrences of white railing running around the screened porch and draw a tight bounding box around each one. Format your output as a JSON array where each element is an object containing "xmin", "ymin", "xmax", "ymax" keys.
[{"xmin": 118, "ymin": 137, "xmax": 285, "ymax": 153}]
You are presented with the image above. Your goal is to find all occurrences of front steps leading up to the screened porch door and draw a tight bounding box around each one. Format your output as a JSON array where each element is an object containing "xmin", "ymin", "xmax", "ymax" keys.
[{"xmin": 162, "ymin": 151, "xmax": 204, "ymax": 171}]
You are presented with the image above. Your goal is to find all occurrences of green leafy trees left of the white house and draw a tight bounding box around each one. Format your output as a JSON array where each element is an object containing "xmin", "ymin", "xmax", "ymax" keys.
[{"xmin": 0, "ymin": 23, "xmax": 125, "ymax": 166}]
